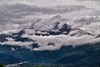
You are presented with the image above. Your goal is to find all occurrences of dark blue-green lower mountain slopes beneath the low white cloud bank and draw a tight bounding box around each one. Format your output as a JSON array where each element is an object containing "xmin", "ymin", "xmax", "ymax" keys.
[{"xmin": 0, "ymin": 43, "xmax": 100, "ymax": 67}]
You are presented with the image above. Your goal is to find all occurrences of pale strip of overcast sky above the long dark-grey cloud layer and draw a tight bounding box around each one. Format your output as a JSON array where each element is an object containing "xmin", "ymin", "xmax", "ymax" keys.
[{"xmin": 0, "ymin": 0, "xmax": 100, "ymax": 9}]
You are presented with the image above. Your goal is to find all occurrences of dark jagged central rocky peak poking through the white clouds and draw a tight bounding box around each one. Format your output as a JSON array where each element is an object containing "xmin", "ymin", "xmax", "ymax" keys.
[{"xmin": 35, "ymin": 23, "xmax": 71, "ymax": 36}]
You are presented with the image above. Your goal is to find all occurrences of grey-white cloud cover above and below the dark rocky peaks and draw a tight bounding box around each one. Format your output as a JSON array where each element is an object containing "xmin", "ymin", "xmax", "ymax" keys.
[{"xmin": 0, "ymin": 0, "xmax": 100, "ymax": 50}]
